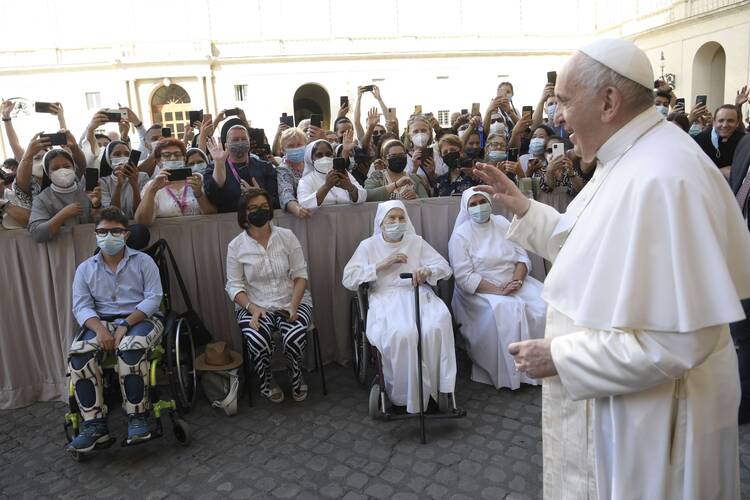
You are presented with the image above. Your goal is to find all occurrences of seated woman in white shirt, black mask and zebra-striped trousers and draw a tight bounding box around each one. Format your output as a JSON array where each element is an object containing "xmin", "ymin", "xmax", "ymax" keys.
[{"xmin": 226, "ymin": 188, "xmax": 312, "ymax": 403}]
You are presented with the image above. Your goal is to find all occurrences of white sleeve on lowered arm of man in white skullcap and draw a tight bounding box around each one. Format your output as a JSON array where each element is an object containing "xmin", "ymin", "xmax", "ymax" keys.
[{"xmin": 551, "ymin": 326, "xmax": 725, "ymax": 400}]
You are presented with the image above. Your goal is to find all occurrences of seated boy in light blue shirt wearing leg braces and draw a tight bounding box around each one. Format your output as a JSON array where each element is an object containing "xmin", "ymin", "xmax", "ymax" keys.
[{"xmin": 68, "ymin": 207, "xmax": 163, "ymax": 452}]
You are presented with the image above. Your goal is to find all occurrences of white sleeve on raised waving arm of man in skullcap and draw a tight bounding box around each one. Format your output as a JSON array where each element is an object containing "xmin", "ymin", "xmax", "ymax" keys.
[{"xmin": 506, "ymin": 200, "xmax": 560, "ymax": 260}]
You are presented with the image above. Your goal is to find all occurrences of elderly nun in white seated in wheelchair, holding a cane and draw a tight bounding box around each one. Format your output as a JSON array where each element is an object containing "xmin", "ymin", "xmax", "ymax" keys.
[{"xmin": 343, "ymin": 200, "xmax": 456, "ymax": 413}]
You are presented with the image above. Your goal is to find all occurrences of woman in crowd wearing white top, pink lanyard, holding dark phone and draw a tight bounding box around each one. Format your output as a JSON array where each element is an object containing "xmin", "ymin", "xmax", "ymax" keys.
[{"xmin": 135, "ymin": 139, "xmax": 216, "ymax": 225}]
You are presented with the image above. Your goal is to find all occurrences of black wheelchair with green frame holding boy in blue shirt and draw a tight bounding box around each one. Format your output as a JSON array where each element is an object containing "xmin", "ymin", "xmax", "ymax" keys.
[{"xmin": 64, "ymin": 239, "xmax": 210, "ymax": 461}]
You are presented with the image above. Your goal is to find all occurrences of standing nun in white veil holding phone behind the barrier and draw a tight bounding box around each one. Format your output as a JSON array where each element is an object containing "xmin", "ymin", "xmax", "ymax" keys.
[{"xmin": 297, "ymin": 139, "xmax": 367, "ymax": 210}]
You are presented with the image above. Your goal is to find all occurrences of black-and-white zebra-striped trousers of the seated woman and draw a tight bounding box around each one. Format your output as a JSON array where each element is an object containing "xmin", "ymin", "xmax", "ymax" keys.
[{"xmin": 237, "ymin": 304, "xmax": 312, "ymax": 397}]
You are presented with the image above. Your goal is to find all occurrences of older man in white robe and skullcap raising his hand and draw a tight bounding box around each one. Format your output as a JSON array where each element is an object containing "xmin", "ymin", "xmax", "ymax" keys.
[{"xmin": 477, "ymin": 40, "xmax": 750, "ymax": 500}]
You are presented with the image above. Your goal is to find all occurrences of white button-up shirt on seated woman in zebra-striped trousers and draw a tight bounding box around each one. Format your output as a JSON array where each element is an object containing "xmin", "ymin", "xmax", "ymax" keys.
[{"xmin": 226, "ymin": 224, "xmax": 312, "ymax": 310}]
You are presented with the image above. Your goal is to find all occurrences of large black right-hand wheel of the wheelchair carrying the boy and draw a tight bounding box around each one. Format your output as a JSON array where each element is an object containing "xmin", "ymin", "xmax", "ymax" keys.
[{"xmin": 167, "ymin": 318, "xmax": 197, "ymax": 413}]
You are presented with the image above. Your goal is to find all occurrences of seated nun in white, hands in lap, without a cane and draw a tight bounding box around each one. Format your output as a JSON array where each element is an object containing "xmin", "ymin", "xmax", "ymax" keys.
[{"xmin": 448, "ymin": 188, "xmax": 547, "ymax": 389}]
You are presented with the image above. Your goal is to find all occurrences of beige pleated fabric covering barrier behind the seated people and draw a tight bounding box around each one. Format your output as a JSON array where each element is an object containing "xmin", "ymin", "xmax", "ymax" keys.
[{"xmin": 0, "ymin": 197, "xmax": 544, "ymax": 409}]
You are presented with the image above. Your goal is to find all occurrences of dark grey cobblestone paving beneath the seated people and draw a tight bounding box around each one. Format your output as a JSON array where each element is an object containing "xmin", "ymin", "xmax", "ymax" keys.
[{"xmin": 0, "ymin": 362, "xmax": 750, "ymax": 500}]
